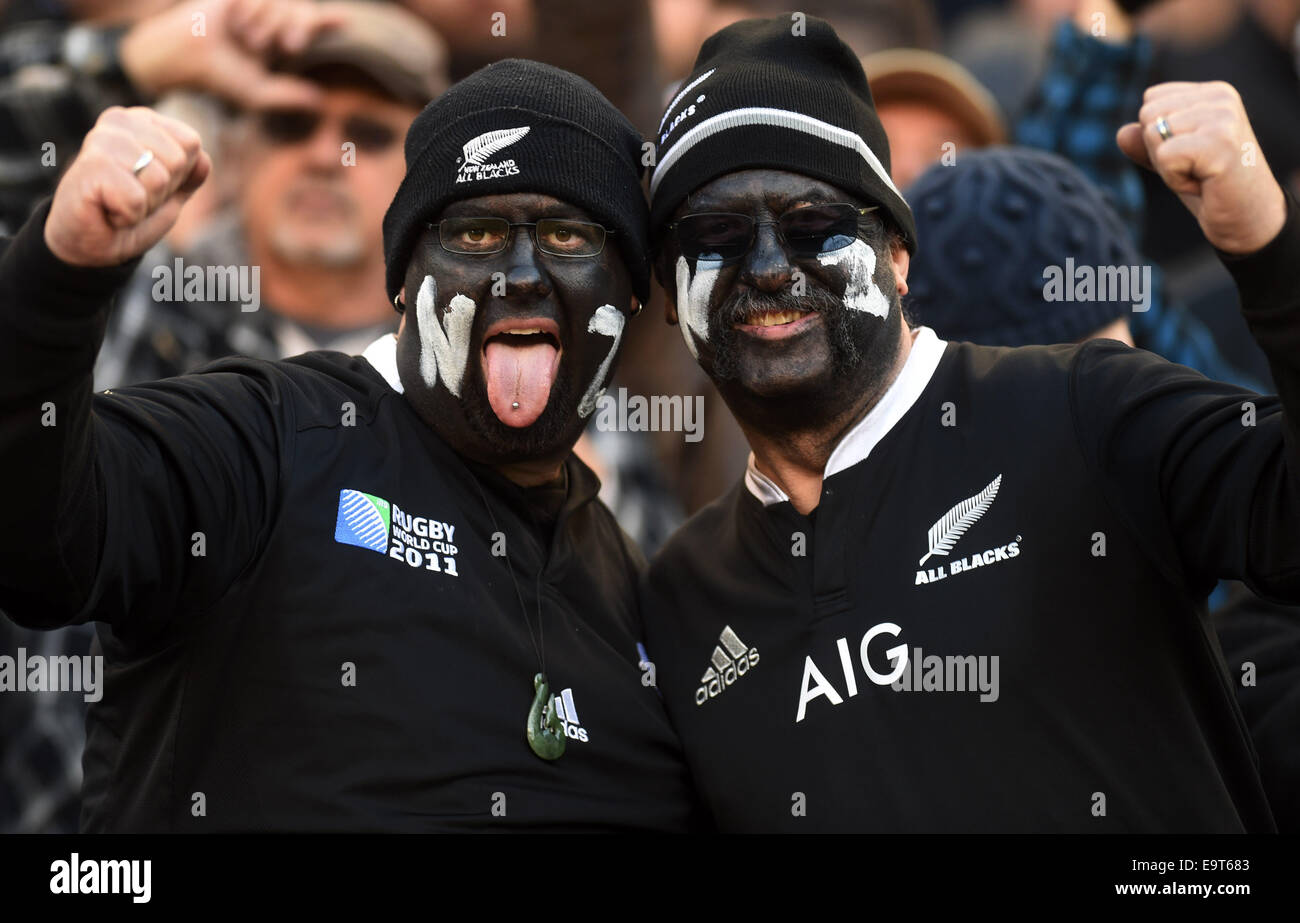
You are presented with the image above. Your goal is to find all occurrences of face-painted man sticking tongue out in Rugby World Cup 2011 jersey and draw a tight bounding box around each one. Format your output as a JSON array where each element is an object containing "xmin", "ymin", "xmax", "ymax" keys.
[{"xmin": 0, "ymin": 61, "xmax": 696, "ymax": 832}]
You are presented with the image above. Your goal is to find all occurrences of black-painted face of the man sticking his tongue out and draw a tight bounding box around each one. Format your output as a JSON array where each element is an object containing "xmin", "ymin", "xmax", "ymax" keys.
[{"xmin": 398, "ymin": 194, "xmax": 632, "ymax": 464}]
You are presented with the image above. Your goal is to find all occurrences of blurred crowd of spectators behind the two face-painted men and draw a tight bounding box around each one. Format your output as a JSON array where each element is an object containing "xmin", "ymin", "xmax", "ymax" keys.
[{"xmin": 0, "ymin": 0, "xmax": 1300, "ymax": 831}]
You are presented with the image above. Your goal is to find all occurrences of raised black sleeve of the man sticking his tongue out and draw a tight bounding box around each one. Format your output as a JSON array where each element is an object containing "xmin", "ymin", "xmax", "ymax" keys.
[{"xmin": 0, "ymin": 198, "xmax": 293, "ymax": 638}]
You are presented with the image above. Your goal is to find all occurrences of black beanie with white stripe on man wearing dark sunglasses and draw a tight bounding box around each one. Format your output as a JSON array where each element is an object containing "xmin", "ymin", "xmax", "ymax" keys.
[{"xmin": 650, "ymin": 14, "xmax": 917, "ymax": 252}]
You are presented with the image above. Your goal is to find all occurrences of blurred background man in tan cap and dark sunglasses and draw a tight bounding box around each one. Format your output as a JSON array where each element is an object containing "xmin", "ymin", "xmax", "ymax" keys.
[{"xmin": 96, "ymin": 3, "xmax": 447, "ymax": 387}]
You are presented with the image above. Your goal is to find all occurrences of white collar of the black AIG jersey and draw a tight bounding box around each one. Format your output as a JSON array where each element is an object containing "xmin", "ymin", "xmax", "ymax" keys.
[{"xmin": 745, "ymin": 326, "xmax": 948, "ymax": 507}]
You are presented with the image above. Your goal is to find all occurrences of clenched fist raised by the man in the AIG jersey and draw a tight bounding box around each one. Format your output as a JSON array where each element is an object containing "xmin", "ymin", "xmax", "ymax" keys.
[{"xmin": 1115, "ymin": 81, "xmax": 1287, "ymax": 254}]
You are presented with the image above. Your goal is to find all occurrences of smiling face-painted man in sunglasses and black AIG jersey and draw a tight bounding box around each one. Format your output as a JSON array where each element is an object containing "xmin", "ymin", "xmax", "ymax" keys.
[{"xmin": 642, "ymin": 18, "xmax": 1300, "ymax": 832}]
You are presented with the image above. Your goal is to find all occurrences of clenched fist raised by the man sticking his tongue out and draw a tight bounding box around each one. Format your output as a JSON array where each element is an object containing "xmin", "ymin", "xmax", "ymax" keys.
[{"xmin": 46, "ymin": 107, "xmax": 212, "ymax": 267}]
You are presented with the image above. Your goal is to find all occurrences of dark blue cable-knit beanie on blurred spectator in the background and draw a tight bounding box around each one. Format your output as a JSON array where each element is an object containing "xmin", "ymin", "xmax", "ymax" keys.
[{"xmin": 905, "ymin": 147, "xmax": 1151, "ymax": 346}]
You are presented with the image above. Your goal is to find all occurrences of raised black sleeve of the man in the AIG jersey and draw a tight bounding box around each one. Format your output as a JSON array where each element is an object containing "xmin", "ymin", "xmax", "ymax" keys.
[{"xmin": 1070, "ymin": 195, "xmax": 1300, "ymax": 602}]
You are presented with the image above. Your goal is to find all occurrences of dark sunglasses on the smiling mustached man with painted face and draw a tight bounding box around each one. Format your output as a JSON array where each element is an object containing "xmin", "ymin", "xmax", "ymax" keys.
[{"xmin": 668, "ymin": 203, "xmax": 879, "ymax": 263}]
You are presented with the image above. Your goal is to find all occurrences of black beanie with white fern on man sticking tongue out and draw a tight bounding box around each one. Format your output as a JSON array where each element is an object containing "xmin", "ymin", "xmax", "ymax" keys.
[{"xmin": 384, "ymin": 59, "xmax": 650, "ymax": 304}]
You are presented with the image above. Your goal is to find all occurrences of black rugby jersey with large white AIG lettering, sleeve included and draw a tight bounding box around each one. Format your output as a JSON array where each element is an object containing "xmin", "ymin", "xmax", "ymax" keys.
[{"xmin": 642, "ymin": 193, "xmax": 1300, "ymax": 832}]
